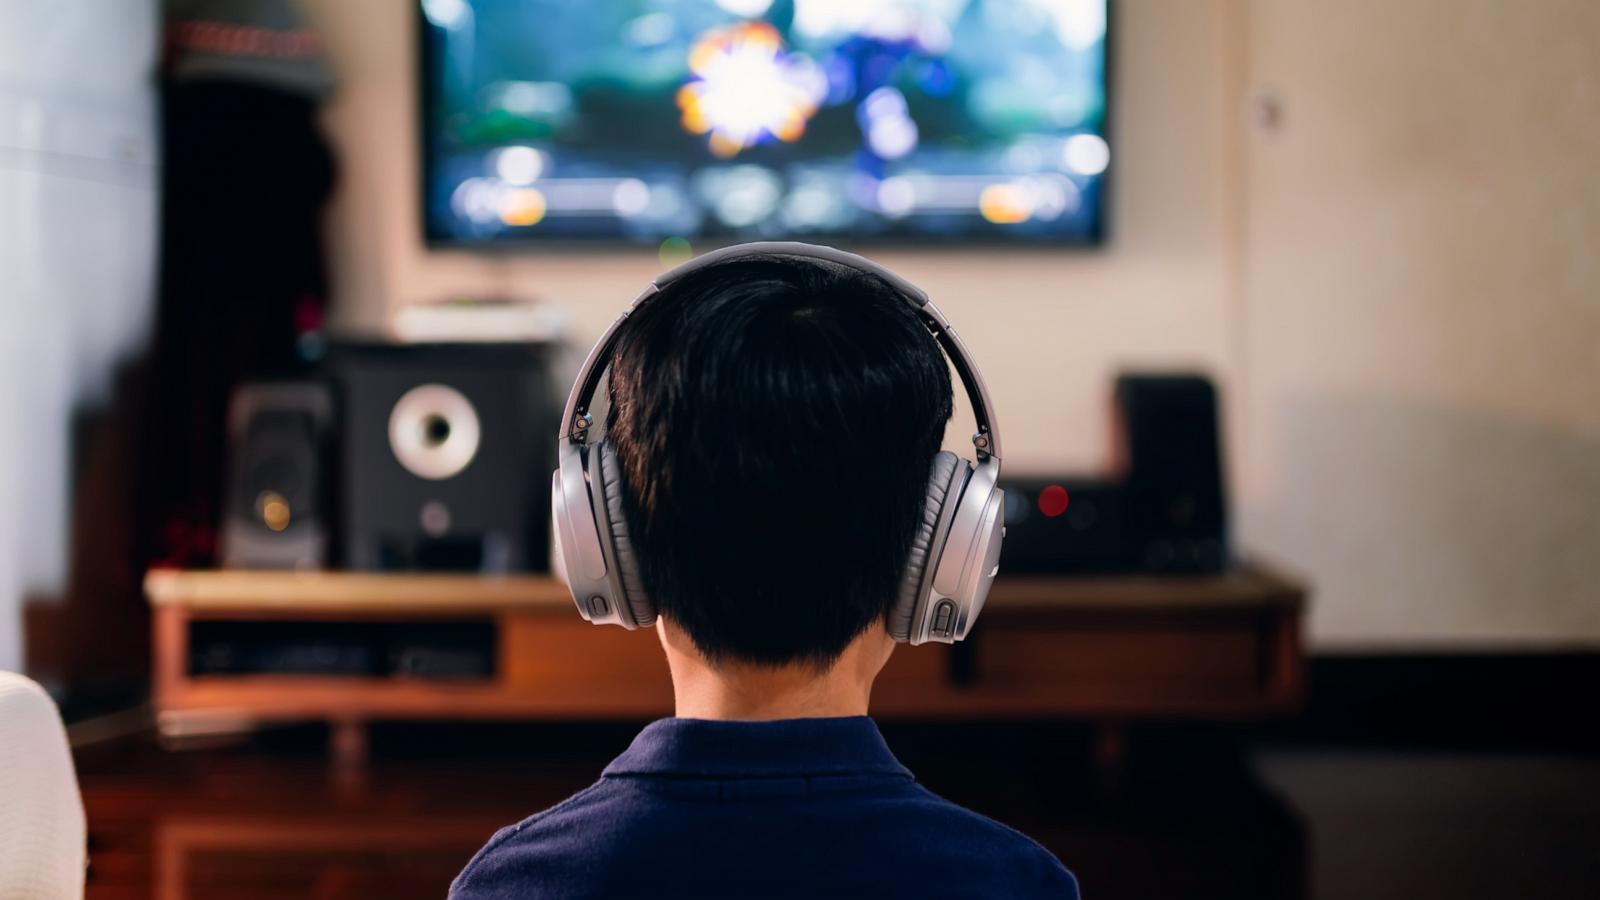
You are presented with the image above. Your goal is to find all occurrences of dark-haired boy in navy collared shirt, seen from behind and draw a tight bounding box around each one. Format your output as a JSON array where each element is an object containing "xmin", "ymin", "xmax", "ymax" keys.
[{"xmin": 451, "ymin": 246, "xmax": 1078, "ymax": 900}]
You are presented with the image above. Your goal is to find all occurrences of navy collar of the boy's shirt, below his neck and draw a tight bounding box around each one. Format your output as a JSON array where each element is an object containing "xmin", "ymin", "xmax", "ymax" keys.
[{"xmin": 605, "ymin": 716, "xmax": 912, "ymax": 778}]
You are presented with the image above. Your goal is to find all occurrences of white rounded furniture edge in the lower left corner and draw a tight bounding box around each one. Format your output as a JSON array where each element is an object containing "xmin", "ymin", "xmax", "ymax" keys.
[{"xmin": 0, "ymin": 673, "xmax": 86, "ymax": 900}]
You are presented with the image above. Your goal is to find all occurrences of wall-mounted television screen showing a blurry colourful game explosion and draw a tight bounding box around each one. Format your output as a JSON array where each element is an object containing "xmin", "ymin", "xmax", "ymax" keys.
[{"xmin": 421, "ymin": 0, "xmax": 1110, "ymax": 243}]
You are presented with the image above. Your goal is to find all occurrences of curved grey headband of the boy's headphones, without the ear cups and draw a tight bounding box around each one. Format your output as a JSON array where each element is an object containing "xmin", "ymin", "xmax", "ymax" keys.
[{"xmin": 560, "ymin": 240, "xmax": 1000, "ymax": 461}]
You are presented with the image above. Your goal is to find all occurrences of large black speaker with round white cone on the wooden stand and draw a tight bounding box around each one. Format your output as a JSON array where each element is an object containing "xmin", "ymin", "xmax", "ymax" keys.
[{"xmin": 331, "ymin": 344, "xmax": 560, "ymax": 572}]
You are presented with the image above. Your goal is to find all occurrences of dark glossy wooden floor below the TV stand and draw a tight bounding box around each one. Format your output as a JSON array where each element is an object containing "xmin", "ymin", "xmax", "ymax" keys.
[{"xmin": 78, "ymin": 724, "xmax": 1600, "ymax": 900}]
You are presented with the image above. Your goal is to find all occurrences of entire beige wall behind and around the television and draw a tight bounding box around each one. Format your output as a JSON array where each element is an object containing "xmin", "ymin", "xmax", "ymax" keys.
[{"xmin": 306, "ymin": 0, "xmax": 1600, "ymax": 647}]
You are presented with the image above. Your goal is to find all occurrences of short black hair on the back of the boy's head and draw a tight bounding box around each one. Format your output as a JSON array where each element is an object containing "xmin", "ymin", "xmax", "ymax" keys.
[{"xmin": 606, "ymin": 256, "xmax": 950, "ymax": 668}]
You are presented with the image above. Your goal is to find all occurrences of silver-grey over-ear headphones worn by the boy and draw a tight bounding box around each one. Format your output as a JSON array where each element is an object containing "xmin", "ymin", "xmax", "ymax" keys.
[{"xmin": 550, "ymin": 242, "xmax": 1005, "ymax": 644}]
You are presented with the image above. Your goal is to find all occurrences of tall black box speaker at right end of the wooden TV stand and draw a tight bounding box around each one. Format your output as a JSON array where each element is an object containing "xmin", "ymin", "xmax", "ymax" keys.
[{"xmin": 1115, "ymin": 375, "xmax": 1229, "ymax": 573}]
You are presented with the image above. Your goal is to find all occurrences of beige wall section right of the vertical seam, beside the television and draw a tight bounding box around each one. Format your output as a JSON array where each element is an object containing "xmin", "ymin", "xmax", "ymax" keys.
[{"xmin": 1242, "ymin": 0, "xmax": 1600, "ymax": 647}]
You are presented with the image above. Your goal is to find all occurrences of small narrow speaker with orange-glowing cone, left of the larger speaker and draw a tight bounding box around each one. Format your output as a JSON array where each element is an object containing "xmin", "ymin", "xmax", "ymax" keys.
[{"xmin": 221, "ymin": 381, "xmax": 333, "ymax": 569}]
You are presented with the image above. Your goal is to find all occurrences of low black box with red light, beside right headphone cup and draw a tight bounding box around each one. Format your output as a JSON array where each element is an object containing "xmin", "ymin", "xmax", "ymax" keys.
[{"xmin": 1000, "ymin": 477, "xmax": 1134, "ymax": 575}]
